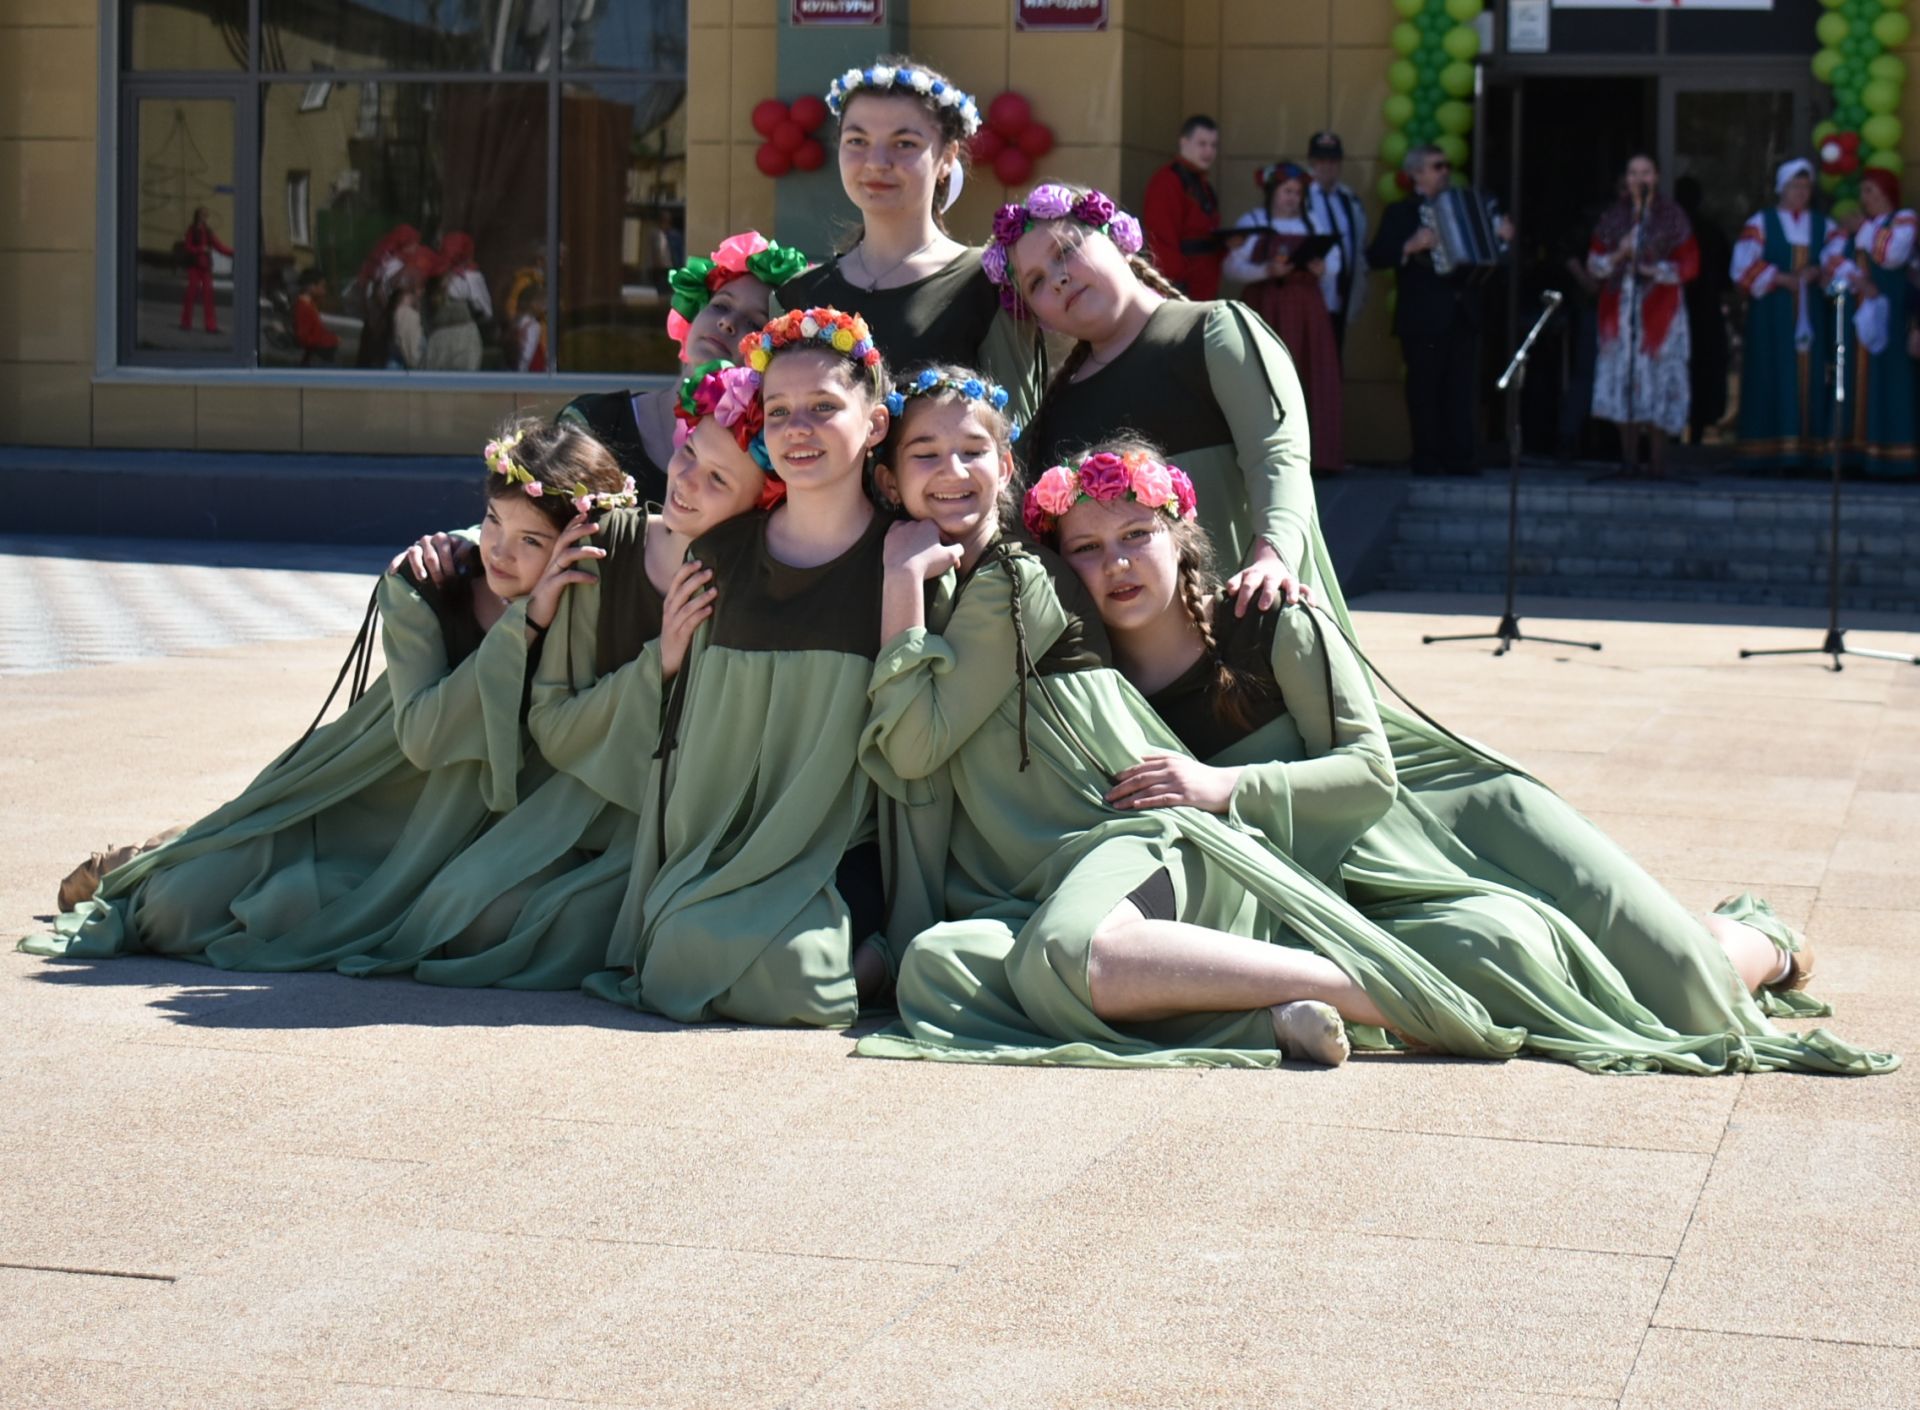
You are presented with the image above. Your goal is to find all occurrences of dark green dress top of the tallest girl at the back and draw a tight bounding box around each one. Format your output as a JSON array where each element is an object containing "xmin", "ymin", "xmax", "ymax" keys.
[{"xmin": 774, "ymin": 246, "xmax": 1046, "ymax": 425}]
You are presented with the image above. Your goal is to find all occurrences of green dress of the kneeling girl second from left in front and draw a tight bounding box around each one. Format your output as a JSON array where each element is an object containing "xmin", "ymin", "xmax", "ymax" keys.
[{"xmin": 340, "ymin": 509, "xmax": 662, "ymax": 989}]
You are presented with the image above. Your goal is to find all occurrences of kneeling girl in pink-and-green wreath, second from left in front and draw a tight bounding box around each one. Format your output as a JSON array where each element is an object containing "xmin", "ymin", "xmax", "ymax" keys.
[{"xmin": 340, "ymin": 363, "xmax": 783, "ymax": 989}]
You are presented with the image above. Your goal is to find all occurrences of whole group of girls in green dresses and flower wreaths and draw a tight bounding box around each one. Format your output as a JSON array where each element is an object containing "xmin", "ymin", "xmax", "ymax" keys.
[{"xmin": 23, "ymin": 49, "xmax": 1897, "ymax": 1074}]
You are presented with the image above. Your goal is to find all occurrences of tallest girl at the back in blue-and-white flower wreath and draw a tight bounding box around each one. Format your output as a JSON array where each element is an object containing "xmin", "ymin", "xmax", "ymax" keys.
[{"xmin": 776, "ymin": 54, "xmax": 1046, "ymax": 428}]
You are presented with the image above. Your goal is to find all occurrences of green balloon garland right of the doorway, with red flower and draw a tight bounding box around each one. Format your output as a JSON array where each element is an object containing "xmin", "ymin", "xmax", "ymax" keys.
[{"xmin": 1812, "ymin": 0, "xmax": 1912, "ymax": 209}]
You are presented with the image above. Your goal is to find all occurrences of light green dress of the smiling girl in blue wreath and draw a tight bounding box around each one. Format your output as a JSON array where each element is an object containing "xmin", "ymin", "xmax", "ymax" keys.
[{"xmin": 858, "ymin": 544, "xmax": 1523, "ymax": 1066}]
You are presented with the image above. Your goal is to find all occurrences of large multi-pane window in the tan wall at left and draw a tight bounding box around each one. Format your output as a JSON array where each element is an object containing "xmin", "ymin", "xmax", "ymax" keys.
[{"xmin": 119, "ymin": 0, "xmax": 687, "ymax": 377}]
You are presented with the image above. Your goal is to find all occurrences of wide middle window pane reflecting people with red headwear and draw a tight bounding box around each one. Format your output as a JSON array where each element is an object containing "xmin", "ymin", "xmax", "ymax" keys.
[{"xmin": 259, "ymin": 83, "xmax": 547, "ymax": 373}]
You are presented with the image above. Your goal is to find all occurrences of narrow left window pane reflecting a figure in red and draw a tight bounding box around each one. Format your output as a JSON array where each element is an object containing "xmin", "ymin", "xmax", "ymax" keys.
[{"xmin": 132, "ymin": 98, "xmax": 236, "ymax": 353}]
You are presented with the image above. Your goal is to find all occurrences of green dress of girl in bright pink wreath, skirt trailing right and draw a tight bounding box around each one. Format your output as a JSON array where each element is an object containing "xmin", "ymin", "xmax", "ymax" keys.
[{"xmin": 1148, "ymin": 601, "xmax": 1897, "ymax": 1074}]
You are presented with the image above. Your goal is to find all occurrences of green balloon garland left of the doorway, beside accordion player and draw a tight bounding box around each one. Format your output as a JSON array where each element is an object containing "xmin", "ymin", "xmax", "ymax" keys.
[{"xmin": 1379, "ymin": 0, "xmax": 1482, "ymax": 202}]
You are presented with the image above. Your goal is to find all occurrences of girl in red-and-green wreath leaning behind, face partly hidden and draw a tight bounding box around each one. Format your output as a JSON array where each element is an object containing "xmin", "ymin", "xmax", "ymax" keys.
[{"xmin": 561, "ymin": 231, "xmax": 806, "ymax": 503}]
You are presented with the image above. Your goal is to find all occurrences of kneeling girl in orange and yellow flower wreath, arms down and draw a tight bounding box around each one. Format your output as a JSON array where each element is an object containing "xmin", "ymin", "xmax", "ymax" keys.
[{"xmin": 586, "ymin": 307, "xmax": 904, "ymax": 1028}]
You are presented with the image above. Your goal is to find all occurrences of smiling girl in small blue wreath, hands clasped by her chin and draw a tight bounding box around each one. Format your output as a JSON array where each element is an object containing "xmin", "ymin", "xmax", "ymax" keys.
[{"xmin": 860, "ymin": 403, "xmax": 1519, "ymax": 1066}]
